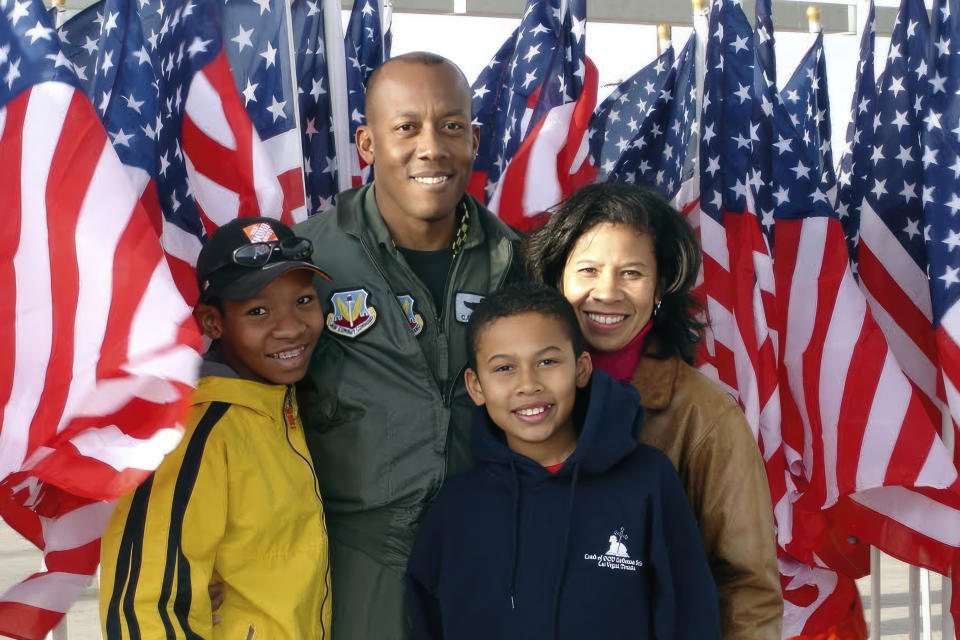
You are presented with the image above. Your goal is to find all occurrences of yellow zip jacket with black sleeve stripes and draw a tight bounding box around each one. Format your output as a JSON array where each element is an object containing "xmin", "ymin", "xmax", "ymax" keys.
[{"xmin": 100, "ymin": 372, "xmax": 331, "ymax": 640}]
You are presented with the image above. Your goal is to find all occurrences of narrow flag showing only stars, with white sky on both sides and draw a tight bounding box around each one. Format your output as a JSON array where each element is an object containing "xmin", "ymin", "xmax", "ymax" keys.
[{"xmin": 780, "ymin": 33, "xmax": 837, "ymax": 201}]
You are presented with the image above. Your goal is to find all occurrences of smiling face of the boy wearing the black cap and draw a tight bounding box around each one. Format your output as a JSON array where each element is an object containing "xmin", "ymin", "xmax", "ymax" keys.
[{"xmin": 198, "ymin": 269, "xmax": 323, "ymax": 384}]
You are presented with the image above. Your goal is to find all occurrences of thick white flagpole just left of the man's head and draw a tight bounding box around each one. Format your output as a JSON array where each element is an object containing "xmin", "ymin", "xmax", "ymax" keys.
[{"xmin": 321, "ymin": 0, "xmax": 353, "ymax": 192}]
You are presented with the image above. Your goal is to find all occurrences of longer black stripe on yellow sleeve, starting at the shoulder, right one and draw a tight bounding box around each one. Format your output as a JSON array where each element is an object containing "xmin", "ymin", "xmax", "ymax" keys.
[{"xmin": 157, "ymin": 402, "xmax": 230, "ymax": 640}]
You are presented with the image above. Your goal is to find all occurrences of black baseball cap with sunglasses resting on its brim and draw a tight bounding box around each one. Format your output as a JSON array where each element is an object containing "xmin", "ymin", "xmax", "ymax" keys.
[{"xmin": 197, "ymin": 218, "xmax": 330, "ymax": 301}]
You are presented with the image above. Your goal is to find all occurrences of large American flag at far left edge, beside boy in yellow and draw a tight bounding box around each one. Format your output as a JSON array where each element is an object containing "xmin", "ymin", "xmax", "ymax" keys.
[{"xmin": 0, "ymin": 0, "xmax": 200, "ymax": 639}]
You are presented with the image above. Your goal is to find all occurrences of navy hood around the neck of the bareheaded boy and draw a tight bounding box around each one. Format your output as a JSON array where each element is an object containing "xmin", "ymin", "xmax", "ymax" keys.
[{"xmin": 473, "ymin": 369, "xmax": 643, "ymax": 475}]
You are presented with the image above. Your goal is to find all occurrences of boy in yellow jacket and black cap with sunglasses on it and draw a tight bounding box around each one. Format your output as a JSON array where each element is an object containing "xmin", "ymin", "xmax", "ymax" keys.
[{"xmin": 100, "ymin": 218, "xmax": 331, "ymax": 640}]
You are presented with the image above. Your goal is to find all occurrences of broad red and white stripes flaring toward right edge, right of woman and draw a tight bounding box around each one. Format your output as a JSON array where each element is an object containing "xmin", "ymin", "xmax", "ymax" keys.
[{"xmin": 774, "ymin": 218, "xmax": 957, "ymax": 508}]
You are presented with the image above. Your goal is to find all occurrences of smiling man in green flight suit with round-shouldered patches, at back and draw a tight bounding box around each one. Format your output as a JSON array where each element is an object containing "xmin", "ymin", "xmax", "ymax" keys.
[{"xmin": 295, "ymin": 53, "xmax": 523, "ymax": 640}]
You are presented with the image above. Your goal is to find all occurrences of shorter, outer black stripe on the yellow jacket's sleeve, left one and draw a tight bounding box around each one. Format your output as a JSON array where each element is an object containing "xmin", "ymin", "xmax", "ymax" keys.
[{"xmin": 104, "ymin": 474, "xmax": 153, "ymax": 640}]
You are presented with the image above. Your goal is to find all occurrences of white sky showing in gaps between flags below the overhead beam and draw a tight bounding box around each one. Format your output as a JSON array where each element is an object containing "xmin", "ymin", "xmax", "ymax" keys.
[{"xmin": 384, "ymin": 13, "xmax": 890, "ymax": 170}]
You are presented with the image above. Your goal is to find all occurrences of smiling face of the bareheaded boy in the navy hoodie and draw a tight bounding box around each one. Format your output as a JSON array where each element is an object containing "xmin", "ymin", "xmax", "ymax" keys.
[{"xmin": 465, "ymin": 313, "xmax": 592, "ymax": 465}]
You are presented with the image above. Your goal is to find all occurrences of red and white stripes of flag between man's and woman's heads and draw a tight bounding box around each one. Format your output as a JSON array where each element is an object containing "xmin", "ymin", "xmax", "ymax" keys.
[{"xmin": 487, "ymin": 58, "xmax": 599, "ymax": 231}]
